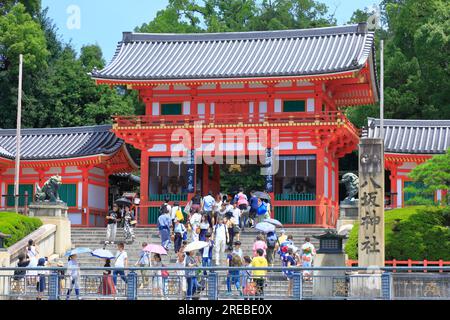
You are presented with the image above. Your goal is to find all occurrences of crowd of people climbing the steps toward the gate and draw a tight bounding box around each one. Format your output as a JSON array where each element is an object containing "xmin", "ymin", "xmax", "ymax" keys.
[{"xmin": 10, "ymin": 189, "xmax": 316, "ymax": 300}]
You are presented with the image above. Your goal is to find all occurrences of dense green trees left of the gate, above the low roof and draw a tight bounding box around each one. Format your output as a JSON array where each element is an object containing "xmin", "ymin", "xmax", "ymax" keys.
[{"xmin": 0, "ymin": 1, "xmax": 143, "ymax": 128}]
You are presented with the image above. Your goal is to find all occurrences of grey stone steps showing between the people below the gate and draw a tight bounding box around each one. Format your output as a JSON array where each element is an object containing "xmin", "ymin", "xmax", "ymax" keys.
[{"xmin": 72, "ymin": 228, "xmax": 325, "ymax": 299}]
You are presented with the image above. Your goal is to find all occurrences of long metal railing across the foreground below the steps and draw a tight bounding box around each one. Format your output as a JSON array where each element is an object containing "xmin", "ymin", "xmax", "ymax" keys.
[{"xmin": 0, "ymin": 267, "xmax": 450, "ymax": 300}]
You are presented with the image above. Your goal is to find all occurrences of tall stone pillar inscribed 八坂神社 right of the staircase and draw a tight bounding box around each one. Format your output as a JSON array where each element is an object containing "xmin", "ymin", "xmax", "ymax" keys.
[{"xmin": 358, "ymin": 138, "xmax": 384, "ymax": 267}]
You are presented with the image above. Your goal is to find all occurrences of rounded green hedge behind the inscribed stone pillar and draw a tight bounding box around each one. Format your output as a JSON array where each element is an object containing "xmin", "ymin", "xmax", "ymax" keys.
[{"xmin": 345, "ymin": 206, "xmax": 450, "ymax": 261}]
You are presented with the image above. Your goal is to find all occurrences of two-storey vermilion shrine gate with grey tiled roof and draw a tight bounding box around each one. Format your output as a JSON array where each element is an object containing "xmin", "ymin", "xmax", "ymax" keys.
[{"xmin": 92, "ymin": 24, "xmax": 378, "ymax": 226}]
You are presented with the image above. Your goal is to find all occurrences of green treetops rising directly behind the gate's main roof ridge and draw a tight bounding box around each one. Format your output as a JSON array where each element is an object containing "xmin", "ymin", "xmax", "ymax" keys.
[{"xmin": 136, "ymin": 0, "xmax": 336, "ymax": 33}]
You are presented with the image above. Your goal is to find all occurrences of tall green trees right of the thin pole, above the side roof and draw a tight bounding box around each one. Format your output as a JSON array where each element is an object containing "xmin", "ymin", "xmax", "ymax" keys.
[{"xmin": 383, "ymin": 0, "xmax": 450, "ymax": 119}]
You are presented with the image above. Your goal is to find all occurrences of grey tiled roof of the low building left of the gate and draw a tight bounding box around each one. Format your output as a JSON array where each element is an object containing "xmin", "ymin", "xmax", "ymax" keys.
[{"xmin": 0, "ymin": 125, "xmax": 124, "ymax": 160}]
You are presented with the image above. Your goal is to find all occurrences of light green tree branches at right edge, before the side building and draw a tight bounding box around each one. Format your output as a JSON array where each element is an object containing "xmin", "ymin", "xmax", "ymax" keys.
[{"xmin": 405, "ymin": 148, "xmax": 450, "ymax": 204}]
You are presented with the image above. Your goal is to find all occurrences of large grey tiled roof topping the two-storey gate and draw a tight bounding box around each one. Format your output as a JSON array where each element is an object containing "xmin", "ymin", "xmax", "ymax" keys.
[{"xmin": 92, "ymin": 24, "xmax": 374, "ymax": 80}]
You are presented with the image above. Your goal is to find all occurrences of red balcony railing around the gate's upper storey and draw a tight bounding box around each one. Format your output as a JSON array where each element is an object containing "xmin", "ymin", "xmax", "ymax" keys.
[{"xmin": 113, "ymin": 111, "xmax": 359, "ymax": 135}]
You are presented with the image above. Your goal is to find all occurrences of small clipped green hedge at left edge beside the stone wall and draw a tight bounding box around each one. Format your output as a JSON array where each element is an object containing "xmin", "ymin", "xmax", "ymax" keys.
[{"xmin": 0, "ymin": 212, "xmax": 42, "ymax": 247}]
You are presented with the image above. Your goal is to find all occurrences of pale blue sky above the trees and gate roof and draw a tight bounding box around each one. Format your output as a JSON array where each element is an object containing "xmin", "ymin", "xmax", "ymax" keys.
[{"xmin": 42, "ymin": 0, "xmax": 380, "ymax": 61}]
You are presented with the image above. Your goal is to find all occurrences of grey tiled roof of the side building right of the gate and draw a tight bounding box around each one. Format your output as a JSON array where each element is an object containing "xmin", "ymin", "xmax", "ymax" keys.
[{"xmin": 368, "ymin": 118, "xmax": 450, "ymax": 154}]
